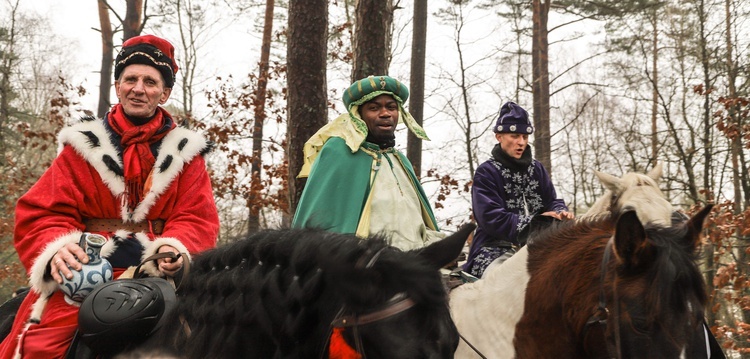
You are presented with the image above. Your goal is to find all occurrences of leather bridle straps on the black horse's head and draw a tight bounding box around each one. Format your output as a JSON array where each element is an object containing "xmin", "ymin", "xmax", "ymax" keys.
[{"xmin": 320, "ymin": 247, "xmax": 416, "ymax": 359}]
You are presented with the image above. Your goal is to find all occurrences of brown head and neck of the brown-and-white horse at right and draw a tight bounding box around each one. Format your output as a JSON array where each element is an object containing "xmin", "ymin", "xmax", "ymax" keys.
[{"xmin": 514, "ymin": 205, "xmax": 712, "ymax": 358}]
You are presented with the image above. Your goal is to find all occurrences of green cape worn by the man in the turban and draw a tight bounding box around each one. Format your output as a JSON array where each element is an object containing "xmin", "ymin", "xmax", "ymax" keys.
[{"xmin": 292, "ymin": 137, "xmax": 438, "ymax": 237}]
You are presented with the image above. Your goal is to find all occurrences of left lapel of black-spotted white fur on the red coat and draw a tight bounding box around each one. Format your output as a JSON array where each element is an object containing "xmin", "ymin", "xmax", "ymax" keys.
[{"xmin": 57, "ymin": 119, "xmax": 125, "ymax": 197}]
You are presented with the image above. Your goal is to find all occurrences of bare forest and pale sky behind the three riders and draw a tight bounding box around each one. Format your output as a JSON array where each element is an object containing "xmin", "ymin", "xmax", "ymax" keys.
[{"xmin": 0, "ymin": 0, "xmax": 750, "ymax": 358}]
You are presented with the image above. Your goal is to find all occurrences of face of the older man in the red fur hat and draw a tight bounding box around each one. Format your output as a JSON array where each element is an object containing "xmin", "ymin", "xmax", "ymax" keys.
[{"xmin": 115, "ymin": 64, "xmax": 172, "ymax": 118}]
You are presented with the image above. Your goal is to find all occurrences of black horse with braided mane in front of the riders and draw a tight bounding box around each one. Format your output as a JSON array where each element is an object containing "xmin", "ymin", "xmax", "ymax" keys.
[{"xmin": 102, "ymin": 224, "xmax": 475, "ymax": 358}]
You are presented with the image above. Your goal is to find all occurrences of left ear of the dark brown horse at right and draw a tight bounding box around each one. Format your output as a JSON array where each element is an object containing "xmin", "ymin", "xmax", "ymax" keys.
[{"xmin": 614, "ymin": 211, "xmax": 653, "ymax": 270}]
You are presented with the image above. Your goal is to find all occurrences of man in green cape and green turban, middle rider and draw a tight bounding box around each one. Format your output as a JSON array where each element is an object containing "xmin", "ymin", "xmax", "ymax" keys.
[{"xmin": 292, "ymin": 76, "xmax": 444, "ymax": 250}]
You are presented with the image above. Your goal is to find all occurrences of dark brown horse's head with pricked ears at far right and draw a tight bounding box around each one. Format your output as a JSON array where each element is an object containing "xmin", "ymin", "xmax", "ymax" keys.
[{"xmin": 600, "ymin": 205, "xmax": 712, "ymax": 358}]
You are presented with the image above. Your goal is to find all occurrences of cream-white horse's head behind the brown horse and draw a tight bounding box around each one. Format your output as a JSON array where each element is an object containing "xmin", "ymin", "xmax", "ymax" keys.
[{"xmin": 583, "ymin": 163, "xmax": 674, "ymax": 226}]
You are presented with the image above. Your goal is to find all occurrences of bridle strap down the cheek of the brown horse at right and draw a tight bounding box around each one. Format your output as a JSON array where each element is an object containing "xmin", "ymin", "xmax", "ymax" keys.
[{"xmin": 583, "ymin": 237, "xmax": 622, "ymax": 359}]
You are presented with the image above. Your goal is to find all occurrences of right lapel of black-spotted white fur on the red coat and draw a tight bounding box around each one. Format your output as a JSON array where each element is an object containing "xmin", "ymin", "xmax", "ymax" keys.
[{"xmin": 130, "ymin": 127, "xmax": 208, "ymax": 223}]
